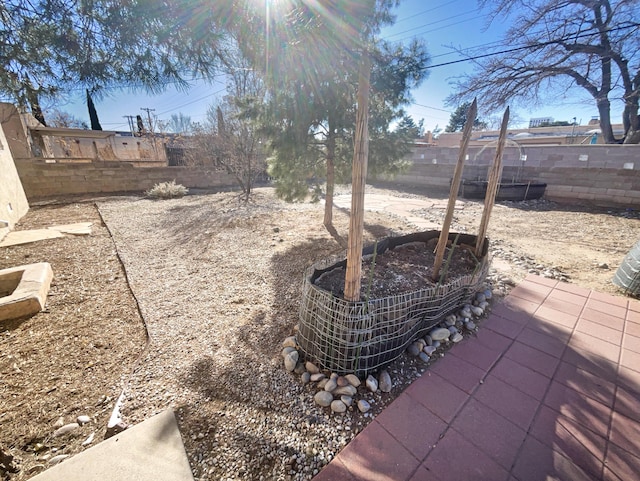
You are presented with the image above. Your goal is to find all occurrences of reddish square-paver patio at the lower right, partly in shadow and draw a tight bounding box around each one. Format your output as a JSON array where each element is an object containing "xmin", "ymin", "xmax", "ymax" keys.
[{"xmin": 314, "ymin": 276, "xmax": 640, "ymax": 481}]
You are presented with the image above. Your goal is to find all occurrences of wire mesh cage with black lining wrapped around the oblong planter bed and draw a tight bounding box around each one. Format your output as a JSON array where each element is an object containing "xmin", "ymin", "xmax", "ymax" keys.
[{"xmin": 297, "ymin": 231, "xmax": 490, "ymax": 376}]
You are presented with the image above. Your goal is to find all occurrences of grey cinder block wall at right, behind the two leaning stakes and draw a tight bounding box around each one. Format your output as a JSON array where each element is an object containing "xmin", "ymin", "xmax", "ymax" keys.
[{"xmin": 387, "ymin": 145, "xmax": 640, "ymax": 207}]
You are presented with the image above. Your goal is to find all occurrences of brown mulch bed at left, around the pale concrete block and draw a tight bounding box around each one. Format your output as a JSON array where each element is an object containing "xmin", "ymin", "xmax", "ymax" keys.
[{"xmin": 0, "ymin": 203, "xmax": 145, "ymax": 479}]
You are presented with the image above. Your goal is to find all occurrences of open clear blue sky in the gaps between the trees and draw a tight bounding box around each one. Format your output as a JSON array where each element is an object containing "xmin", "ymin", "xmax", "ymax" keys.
[{"xmin": 57, "ymin": 0, "xmax": 608, "ymax": 130}]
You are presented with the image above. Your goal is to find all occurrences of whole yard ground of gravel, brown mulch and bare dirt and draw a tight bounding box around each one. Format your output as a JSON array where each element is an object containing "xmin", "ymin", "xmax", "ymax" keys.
[{"xmin": 0, "ymin": 188, "xmax": 640, "ymax": 480}]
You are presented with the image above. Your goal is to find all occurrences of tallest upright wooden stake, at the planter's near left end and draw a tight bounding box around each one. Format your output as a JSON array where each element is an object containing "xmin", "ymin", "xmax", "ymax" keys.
[{"xmin": 344, "ymin": 52, "xmax": 371, "ymax": 302}]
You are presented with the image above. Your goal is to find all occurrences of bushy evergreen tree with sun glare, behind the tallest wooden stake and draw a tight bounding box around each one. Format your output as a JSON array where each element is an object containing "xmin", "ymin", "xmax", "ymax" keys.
[{"xmin": 240, "ymin": 0, "xmax": 429, "ymax": 238}]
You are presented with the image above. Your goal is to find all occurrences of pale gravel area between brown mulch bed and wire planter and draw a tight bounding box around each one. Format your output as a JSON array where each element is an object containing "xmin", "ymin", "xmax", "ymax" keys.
[{"xmin": 99, "ymin": 191, "xmax": 417, "ymax": 480}]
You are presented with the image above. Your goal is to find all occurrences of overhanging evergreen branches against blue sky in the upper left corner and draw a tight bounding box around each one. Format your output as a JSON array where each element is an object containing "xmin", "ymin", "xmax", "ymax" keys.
[{"xmin": 0, "ymin": 0, "xmax": 228, "ymax": 121}]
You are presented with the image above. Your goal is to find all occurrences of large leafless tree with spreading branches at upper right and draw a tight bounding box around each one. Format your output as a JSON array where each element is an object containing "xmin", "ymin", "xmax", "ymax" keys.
[{"xmin": 448, "ymin": 0, "xmax": 640, "ymax": 143}]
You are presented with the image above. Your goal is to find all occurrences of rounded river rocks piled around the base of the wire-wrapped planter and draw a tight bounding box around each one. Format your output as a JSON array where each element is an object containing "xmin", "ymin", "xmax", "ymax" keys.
[{"xmin": 282, "ymin": 288, "xmax": 492, "ymax": 417}]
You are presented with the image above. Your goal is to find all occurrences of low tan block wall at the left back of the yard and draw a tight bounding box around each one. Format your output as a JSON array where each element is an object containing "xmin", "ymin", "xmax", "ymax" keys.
[{"xmin": 15, "ymin": 159, "xmax": 235, "ymax": 201}]
